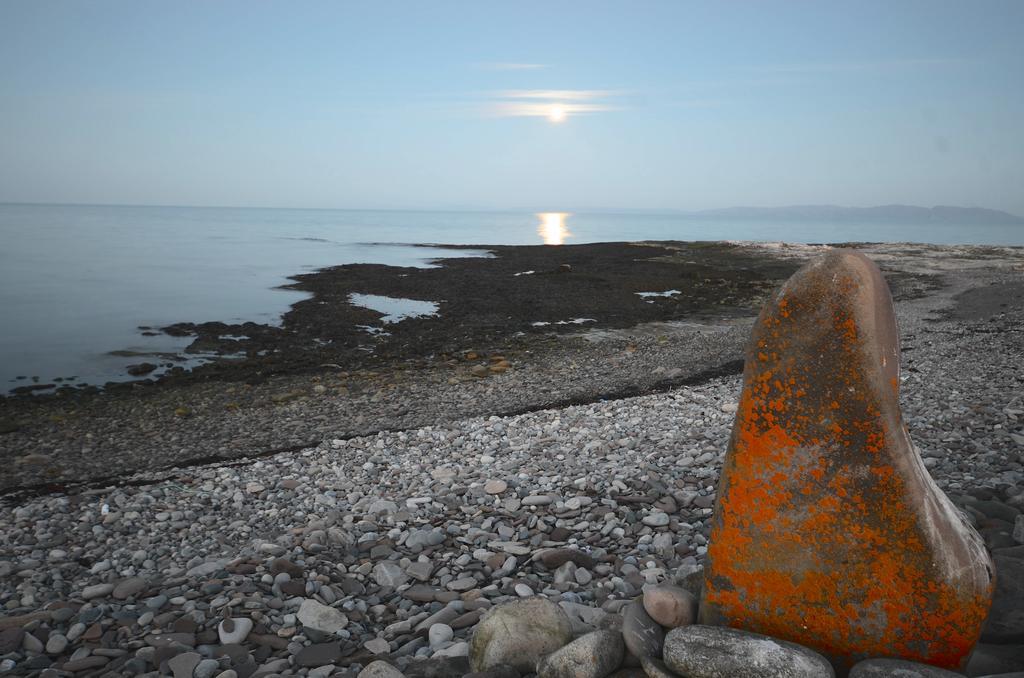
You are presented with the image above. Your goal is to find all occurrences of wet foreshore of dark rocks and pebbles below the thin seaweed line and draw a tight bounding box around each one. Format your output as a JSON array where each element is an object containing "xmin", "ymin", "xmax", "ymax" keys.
[{"xmin": 0, "ymin": 238, "xmax": 999, "ymax": 492}]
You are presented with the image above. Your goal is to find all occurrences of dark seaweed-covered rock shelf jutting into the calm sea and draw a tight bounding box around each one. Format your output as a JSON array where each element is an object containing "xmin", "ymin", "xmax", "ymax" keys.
[{"xmin": 0, "ymin": 243, "xmax": 939, "ymax": 402}]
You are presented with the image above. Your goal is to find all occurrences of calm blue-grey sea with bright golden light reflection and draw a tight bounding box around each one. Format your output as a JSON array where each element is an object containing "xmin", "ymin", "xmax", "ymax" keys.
[{"xmin": 0, "ymin": 205, "xmax": 1024, "ymax": 392}]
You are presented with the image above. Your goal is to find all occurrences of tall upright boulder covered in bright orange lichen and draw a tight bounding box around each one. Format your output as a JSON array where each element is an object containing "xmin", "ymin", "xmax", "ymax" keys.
[{"xmin": 700, "ymin": 250, "xmax": 992, "ymax": 672}]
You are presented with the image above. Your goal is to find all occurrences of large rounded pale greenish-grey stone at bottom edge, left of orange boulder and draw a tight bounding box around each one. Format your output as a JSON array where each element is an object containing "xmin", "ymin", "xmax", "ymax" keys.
[{"xmin": 469, "ymin": 596, "xmax": 572, "ymax": 673}]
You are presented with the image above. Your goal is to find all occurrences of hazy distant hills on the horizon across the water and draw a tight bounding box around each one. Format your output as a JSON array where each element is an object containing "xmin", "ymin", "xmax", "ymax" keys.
[{"xmin": 689, "ymin": 205, "xmax": 1024, "ymax": 224}]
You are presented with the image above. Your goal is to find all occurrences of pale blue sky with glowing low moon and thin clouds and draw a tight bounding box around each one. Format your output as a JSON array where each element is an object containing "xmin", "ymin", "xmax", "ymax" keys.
[{"xmin": 0, "ymin": 0, "xmax": 1024, "ymax": 214}]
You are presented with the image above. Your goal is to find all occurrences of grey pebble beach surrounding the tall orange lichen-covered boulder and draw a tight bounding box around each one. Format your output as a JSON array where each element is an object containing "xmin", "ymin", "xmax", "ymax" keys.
[{"xmin": 0, "ymin": 241, "xmax": 1024, "ymax": 678}]
